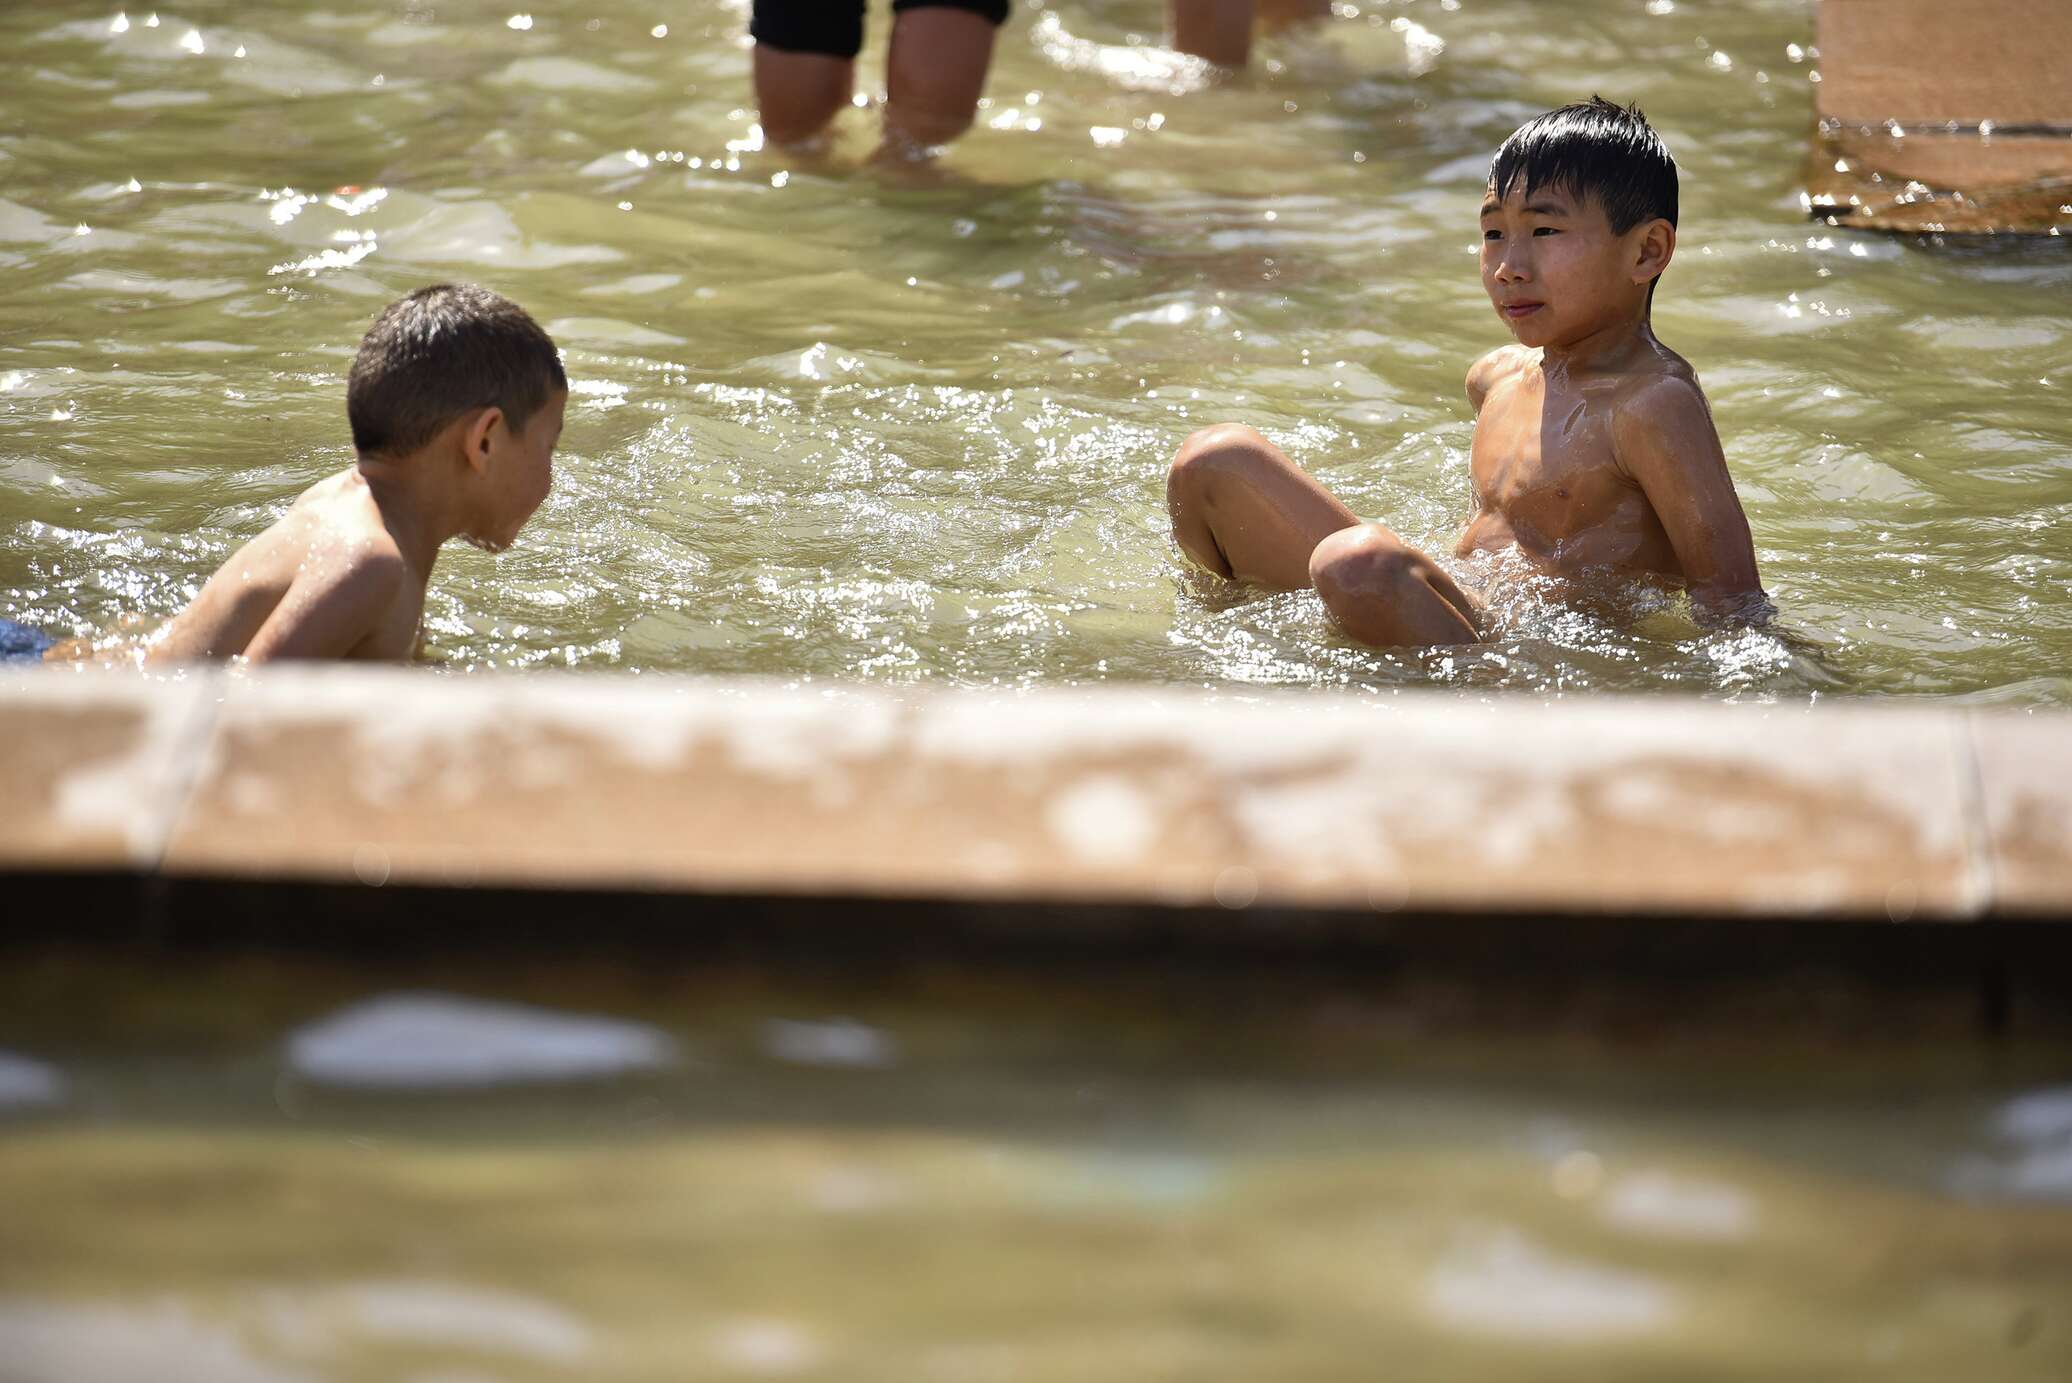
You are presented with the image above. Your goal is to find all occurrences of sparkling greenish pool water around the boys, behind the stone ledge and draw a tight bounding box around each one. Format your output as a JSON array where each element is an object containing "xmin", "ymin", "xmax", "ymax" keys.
[{"xmin": 0, "ymin": 0, "xmax": 2072, "ymax": 705}]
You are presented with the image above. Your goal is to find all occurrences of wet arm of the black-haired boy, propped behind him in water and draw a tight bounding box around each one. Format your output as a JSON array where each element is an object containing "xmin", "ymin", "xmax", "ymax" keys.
[{"xmin": 1612, "ymin": 377, "xmax": 1767, "ymax": 618}]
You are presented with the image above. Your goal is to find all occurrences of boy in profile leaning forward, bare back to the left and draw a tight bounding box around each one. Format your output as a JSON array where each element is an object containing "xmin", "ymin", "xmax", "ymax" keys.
[{"xmin": 145, "ymin": 284, "xmax": 568, "ymax": 664}]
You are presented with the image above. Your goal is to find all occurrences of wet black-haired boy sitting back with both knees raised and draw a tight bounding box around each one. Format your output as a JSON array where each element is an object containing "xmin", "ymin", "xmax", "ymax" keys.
[{"xmin": 1167, "ymin": 97, "xmax": 1767, "ymax": 647}]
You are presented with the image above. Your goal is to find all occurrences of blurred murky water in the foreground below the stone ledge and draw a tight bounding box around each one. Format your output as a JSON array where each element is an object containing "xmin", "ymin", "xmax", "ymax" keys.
[{"xmin": 0, "ymin": 958, "xmax": 2072, "ymax": 1383}]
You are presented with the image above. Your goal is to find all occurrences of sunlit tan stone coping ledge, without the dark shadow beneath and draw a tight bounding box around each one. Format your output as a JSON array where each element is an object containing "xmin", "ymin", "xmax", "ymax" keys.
[{"xmin": 0, "ymin": 668, "xmax": 2072, "ymax": 921}]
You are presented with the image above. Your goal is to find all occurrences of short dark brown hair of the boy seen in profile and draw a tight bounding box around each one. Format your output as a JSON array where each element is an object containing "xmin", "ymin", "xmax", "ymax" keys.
[{"xmin": 346, "ymin": 284, "xmax": 568, "ymax": 456}]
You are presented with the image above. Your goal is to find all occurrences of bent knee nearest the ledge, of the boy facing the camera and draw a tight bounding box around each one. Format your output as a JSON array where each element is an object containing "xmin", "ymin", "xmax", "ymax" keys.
[{"xmin": 1310, "ymin": 523, "xmax": 1479, "ymax": 649}]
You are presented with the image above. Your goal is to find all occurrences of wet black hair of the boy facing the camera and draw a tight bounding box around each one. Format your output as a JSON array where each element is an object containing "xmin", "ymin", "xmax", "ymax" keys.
[{"xmin": 1490, "ymin": 95, "xmax": 1676, "ymax": 234}]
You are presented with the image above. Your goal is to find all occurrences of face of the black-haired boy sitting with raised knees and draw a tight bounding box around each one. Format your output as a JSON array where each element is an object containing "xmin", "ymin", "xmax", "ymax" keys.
[{"xmin": 1481, "ymin": 182, "xmax": 1668, "ymax": 346}]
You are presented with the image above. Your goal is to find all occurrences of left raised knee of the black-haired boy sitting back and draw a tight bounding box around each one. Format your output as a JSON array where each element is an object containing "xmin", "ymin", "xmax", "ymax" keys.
[{"xmin": 1167, "ymin": 423, "xmax": 1359, "ymax": 591}]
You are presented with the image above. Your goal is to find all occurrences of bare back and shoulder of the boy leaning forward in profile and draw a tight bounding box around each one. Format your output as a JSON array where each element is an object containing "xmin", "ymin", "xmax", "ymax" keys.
[{"xmin": 147, "ymin": 469, "xmax": 431, "ymax": 661}]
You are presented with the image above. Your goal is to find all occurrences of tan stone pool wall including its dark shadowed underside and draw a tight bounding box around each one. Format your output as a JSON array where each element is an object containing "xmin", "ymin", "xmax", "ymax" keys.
[{"xmin": 0, "ymin": 668, "xmax": 2072, "ymax": 1035}]
